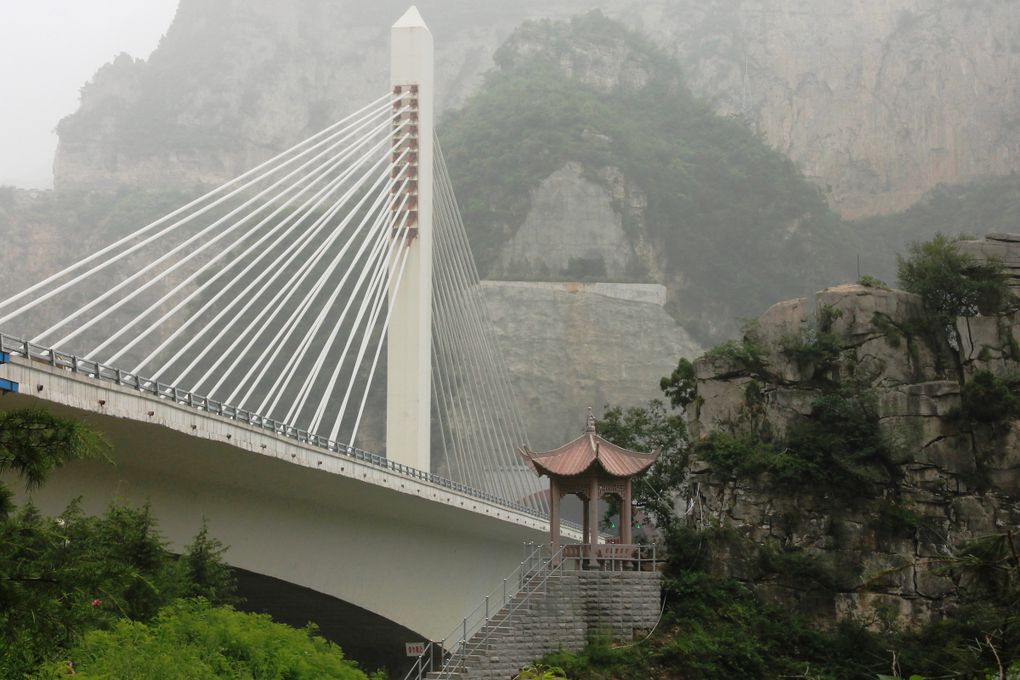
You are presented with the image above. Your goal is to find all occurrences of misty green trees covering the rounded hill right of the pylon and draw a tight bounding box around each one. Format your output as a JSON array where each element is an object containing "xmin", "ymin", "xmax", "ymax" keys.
[{"xmin": 441, "ymin": 13, "xmax": 842, "ymax": 338}]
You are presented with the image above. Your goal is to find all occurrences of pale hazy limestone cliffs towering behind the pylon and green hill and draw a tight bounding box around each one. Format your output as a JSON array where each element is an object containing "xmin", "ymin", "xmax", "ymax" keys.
[{"xmin": 56, "ymin": 0, "xmax": 1020, "ymax": 217}]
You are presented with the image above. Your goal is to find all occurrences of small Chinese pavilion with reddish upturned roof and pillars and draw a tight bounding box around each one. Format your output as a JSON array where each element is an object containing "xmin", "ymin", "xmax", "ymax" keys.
[{"xmin": 520, "ymin": 408, "xmax": 659, "ymax": 563}]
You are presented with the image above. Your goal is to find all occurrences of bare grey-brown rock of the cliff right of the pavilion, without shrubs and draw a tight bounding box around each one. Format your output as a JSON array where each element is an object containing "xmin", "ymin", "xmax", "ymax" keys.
[{"xmin": 680, "ymin": 235, "xmax": 1020, "ymax": 622}]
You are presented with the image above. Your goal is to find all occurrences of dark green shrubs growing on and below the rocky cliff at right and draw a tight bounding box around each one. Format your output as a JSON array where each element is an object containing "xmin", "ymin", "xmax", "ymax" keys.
[{"xmin": 575, "ymin": 238, "xmax": 1020, "ymax": 680}]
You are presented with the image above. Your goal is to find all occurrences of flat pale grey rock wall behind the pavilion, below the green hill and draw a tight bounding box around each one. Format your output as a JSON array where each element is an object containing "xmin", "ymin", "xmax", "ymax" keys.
[{"xmin": 482, "ymin": 281, "xmax": 699, "ymax": 450}]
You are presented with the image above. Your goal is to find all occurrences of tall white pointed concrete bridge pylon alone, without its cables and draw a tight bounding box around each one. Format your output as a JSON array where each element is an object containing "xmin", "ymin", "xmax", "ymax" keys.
[{"xmin": 386, "ymin": 7, "xmax": 435, "ymax": 471}]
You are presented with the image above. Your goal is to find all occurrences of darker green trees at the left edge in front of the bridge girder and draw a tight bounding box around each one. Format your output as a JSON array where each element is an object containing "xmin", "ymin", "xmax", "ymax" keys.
[{"xmin": 0, "ymin": 410, "xmax": 234, "ymax": 678}]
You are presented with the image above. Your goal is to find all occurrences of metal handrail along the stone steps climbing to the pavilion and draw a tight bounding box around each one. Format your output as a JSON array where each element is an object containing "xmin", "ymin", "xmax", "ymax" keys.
[{"xmin": 404, "ymin": 543, "xmax": 563, "ymax": 680}]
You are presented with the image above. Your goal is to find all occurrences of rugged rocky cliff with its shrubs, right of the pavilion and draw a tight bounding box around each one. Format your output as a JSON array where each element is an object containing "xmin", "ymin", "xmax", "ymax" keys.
[{"xmin": 681, "ymin": 236, "xmax": 1020, "ymax": 625}]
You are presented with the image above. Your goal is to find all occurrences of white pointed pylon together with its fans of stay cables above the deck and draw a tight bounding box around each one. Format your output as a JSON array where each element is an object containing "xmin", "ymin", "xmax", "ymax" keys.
[{"xmin": 0, "ymin": 7, "xmax": 548, "ymax": 513}]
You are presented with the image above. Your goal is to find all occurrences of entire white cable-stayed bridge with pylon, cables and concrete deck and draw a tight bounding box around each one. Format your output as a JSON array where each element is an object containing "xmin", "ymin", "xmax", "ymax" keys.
[{"xmin": 0, "ymin": 8, "xmax": 575, "ymax": 652}]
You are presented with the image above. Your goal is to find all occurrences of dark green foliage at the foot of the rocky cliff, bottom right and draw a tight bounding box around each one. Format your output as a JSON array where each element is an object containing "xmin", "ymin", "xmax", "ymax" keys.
[{"xmin": 544, "ymin": 528, "xmax": 1020, "ymax": 680}]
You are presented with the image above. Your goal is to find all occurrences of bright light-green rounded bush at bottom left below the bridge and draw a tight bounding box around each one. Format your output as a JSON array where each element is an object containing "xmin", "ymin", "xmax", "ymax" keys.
[{"xmin": 34, "ymin": 599, "xmax": 379, "ymax": 680}]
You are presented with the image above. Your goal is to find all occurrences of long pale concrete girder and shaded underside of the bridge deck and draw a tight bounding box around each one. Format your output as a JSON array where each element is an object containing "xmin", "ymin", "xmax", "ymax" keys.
[{"xmin": 0, "ymin": 377, "xmax": 548, "ymax": 639}]
